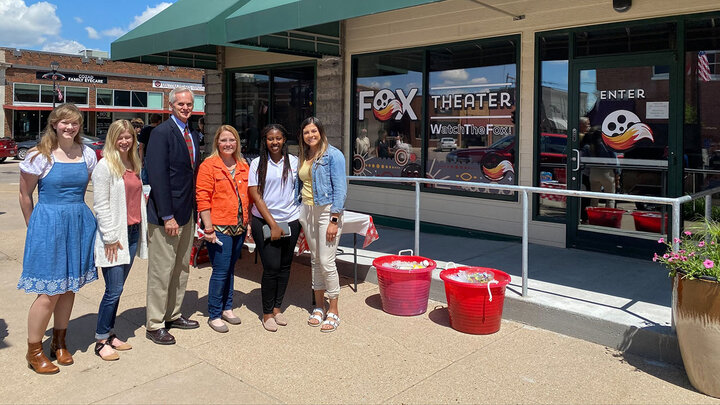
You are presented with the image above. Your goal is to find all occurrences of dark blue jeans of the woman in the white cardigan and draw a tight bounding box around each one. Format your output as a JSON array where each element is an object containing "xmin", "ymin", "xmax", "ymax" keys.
[{"xmin": 95, "ymin": 224, "xmax": 140, "ymax": 340}]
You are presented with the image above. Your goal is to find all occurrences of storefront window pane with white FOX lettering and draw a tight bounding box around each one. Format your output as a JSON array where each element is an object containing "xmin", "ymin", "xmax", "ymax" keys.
[{"xmin": 353, "ymin": 51, "xmax": 425, "ymax": 177}]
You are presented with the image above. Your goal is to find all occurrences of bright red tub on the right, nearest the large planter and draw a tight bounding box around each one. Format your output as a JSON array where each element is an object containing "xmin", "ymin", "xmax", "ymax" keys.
[{"xmin": 440, "ymin": 267, "xmax": 510, "ymax": 335}]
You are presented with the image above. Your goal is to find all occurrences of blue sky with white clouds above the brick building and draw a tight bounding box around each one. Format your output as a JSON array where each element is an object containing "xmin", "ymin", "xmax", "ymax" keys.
[{"xmin": 0, "ymin": 0, "xmax": 175, "ymax": 55}]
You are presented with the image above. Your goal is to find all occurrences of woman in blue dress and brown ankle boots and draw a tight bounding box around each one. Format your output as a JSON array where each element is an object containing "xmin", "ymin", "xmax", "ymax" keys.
[{"xmin": 18, "ymin": 104, "xmax": 97, "ymax": 374}]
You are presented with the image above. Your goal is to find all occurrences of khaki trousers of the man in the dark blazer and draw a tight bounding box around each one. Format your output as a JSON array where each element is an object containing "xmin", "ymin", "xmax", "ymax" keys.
[{"xmin": 145, "ymin": 221, "xmax": 195, "ymax": 331}]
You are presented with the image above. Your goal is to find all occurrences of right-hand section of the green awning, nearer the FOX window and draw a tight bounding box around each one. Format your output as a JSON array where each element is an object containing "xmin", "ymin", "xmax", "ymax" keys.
[{"xmin": 225, "ymin": 0, "xmax": 443, "ymax": 56}]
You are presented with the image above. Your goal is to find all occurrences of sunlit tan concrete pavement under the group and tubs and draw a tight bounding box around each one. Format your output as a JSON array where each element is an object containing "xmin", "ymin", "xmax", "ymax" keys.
[{"xmin": 0, "ymin": 163, "xmax": 720, "ymax": 404}]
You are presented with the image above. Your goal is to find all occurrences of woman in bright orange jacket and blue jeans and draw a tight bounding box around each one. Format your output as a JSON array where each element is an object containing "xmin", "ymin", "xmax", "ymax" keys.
[{"xmin": 196, "ymin": 125, "xmax": 250, "ymax": 333}]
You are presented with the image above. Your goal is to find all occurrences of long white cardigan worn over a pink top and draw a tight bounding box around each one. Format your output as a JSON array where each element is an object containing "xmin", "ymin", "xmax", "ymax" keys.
[{"xmin": 92, "ymin": 159, "xmax": 147, "ymax": 267}]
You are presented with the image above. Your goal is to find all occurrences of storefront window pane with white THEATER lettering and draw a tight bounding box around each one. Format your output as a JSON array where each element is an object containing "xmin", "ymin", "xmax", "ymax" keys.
[{"xmin": 426, "ymin": 41, "xmax": 517, "ymax": 191}]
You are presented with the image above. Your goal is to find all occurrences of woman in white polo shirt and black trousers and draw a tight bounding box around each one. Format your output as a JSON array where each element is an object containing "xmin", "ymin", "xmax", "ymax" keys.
[{"xmin": 248, "ymin": 124, "xmax": 300, "ymax": 332}]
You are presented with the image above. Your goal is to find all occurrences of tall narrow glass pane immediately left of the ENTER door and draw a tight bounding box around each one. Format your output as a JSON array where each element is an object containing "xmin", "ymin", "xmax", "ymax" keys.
[{"xmin": 534, "ymin": 34, "xmax": 572, "ymax": 220}]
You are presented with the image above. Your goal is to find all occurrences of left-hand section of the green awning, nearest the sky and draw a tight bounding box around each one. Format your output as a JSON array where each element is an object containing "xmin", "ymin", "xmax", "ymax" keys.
[{"xmin": 110, "ymin": 0, "xmax": 255, "ymax": 69}]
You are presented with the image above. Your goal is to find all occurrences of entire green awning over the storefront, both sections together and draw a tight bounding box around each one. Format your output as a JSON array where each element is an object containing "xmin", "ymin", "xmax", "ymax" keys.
[{"xmin": 110, "ymin": 0, "xmax": 443, "ymax": 64}]
